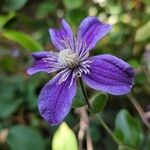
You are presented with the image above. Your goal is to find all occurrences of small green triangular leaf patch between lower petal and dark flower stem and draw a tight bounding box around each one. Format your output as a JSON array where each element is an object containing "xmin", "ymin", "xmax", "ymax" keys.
[{"xmin": 72, "ymin": 87, "xmax": 85, "ymax": 108}]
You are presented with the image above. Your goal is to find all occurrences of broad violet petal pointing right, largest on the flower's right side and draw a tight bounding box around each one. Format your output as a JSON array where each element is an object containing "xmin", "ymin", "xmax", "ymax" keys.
[{"xmin": 82, "ymin": 54, "xmax": 134, "ymax": 95}]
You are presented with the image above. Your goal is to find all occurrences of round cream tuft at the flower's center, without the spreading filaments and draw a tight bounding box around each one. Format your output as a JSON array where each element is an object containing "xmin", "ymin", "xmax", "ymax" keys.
[{"xmin": 58, "ymin": 49, "xmax": 80, "ymax": 68}]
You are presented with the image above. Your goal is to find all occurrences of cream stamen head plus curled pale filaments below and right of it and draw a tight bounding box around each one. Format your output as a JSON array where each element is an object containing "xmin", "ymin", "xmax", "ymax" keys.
[{"xmin": 58, "ymin": 48, "xmax": 92, "ymax": 88}]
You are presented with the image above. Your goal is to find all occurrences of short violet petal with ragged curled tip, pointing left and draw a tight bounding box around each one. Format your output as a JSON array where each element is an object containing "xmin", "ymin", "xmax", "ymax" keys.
[{"xmin": 27, "ymin": 51, "xmax": 62, "ymax": 75}]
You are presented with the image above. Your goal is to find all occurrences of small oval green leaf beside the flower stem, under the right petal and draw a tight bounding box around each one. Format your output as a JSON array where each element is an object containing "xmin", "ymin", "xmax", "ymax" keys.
[{"xmin": 90, "ymin": 94, "xmax": 107, "ymax": 114}]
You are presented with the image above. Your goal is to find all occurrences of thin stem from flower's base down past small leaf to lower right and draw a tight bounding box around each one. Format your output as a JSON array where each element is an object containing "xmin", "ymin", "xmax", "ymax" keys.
[{"xmin": 79, "ymin": 77, "xmax": 135, "ymax": 150}]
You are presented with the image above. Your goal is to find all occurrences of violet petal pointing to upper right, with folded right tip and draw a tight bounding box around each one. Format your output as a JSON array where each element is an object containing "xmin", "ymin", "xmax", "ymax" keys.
[{"xmin": 76, "ymin": 17, "xmax": 112, "ymax": 53}]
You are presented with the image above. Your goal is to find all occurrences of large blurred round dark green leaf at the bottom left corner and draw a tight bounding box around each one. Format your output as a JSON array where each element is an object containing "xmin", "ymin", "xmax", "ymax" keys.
[{"xmin": 7, "ymin": 125, "xmax": 45, "ymax": 150}]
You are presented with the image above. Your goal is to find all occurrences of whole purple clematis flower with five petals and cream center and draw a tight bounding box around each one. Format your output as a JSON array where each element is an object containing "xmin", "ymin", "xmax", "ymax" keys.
[{"xmin": 27, "ymin": 17, "xmax": 134, "ymax": 125}]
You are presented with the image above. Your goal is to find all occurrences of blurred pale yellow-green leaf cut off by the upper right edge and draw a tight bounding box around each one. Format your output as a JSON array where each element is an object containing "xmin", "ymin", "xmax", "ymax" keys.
[{"xmin": 135, "ymin": 21, "xmax": 150, "ymax": 42}]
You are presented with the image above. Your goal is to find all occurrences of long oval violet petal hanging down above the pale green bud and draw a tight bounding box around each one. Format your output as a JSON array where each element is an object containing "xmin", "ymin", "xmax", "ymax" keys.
[{"xmin": 38, "ymin": 72, "xmax": 76, "ymax": 125}]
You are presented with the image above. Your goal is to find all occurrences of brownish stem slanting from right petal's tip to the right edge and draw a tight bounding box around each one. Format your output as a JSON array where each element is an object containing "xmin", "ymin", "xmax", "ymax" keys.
[{"xmin": 128, "ymin": 94, "xmax": 150, "ymax": 130}]
